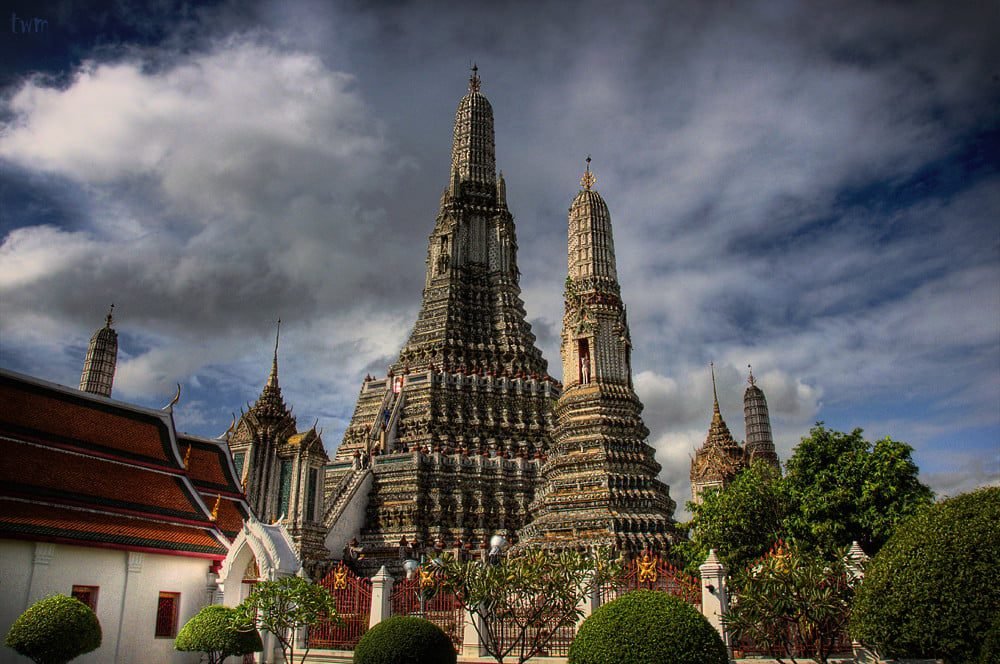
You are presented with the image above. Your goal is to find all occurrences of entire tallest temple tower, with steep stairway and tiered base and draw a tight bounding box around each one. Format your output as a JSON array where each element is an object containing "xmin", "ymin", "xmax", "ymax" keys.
[{"xmin": 326, "ymin": 68, "xmax": 559, "ymax": 570}]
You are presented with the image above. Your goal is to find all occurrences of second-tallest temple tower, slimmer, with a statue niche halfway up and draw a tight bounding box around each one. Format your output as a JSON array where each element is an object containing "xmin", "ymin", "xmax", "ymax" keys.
[{"xmin": 520, "ymin": 157, "xmax": 676, "ymax": 551}]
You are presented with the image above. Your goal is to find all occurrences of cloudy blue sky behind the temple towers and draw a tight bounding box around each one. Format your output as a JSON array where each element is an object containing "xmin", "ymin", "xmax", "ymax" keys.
[{"xmin": 0, "ymin": 0, "xmax": 1000, "ymax": 502}]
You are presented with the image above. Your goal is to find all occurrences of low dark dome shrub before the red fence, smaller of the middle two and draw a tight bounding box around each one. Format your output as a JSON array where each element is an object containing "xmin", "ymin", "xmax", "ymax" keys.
[{"xmin": 354, "ymin": 616, "xmax": 458, "ymax": 664}]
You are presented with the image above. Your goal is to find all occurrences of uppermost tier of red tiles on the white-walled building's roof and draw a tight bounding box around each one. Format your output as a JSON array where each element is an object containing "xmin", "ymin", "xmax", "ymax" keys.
[{"xmin": 0, "ymin": 374, "xmax": 178, "ymax": 468}]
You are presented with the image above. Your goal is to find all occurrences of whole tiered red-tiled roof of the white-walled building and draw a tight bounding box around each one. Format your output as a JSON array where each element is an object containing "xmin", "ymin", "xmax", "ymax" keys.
[{"xmin": 0, "ymin": 370, "xmax": 246, "ymax": 559}]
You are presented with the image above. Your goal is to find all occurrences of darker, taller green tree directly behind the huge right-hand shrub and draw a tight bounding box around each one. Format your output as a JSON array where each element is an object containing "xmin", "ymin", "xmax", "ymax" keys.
[{"xmin": 785, "ymin": 422, "xmax": 934, "ymax": 553}]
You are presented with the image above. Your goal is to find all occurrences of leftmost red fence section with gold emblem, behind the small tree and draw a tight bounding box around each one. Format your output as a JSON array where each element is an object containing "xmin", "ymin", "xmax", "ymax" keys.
[{"xmin": 309, "ymin": 563, "xmax": 372, "ymax": 650}]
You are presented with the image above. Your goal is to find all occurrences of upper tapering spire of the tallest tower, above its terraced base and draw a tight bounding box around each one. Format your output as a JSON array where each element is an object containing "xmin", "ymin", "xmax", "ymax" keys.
[{"xmin": 392, "ymin": 71, "xmax": 547, "ymax": 377}]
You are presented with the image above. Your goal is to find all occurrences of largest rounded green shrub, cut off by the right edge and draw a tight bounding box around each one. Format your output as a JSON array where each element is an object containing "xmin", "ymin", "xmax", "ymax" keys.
[{"xmin": 850, "ymin": 487, "xmax": 1000, "ymax": 664}]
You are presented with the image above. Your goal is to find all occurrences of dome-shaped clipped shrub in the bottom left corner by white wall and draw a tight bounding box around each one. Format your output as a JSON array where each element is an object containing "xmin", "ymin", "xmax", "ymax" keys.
[{"xmin": 4, "ymin": 595, "xmax": 101, "ymax": 664}]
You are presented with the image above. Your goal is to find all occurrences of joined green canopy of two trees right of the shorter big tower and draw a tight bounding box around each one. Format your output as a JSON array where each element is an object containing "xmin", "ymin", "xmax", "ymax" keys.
[{"xmin": 676, "ymin": 423, "xmax": 934, "ymax": 572}]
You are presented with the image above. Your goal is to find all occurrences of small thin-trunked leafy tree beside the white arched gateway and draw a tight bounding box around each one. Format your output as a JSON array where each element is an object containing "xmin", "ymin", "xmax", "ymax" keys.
[{"xmin": 234, "ymin": 576, "xmax": 339, "ymax": 664}]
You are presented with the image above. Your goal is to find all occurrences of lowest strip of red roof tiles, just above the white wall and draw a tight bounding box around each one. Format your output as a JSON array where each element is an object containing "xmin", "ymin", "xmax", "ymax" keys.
[{"xmin": 0, "ymin": 497, "xmax": 226, "ymax": 558}]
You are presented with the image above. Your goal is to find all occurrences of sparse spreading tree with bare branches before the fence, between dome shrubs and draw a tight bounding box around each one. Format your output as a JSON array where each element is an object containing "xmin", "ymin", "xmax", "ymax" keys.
[{"xmin": 441, "ymin": 549, "xmax": 621, "ymax": 664}]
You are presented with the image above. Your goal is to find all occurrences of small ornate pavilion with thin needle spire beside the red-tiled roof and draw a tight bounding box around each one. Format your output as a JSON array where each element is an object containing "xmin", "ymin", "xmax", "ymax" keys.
[{"xmin": 227, "ymin": 321, "xmax": 329, "ymax": 567}]
